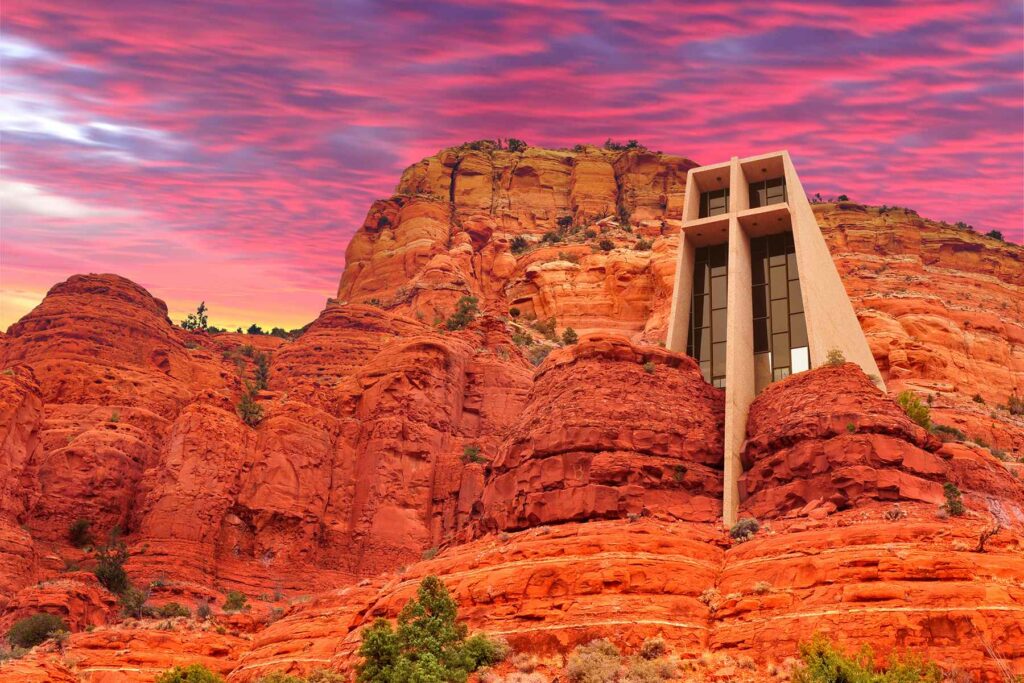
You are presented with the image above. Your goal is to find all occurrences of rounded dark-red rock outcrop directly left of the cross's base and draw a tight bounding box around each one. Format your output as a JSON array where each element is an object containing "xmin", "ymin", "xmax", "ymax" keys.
[{"xmin": 479, "ymin": 337, "xmax": 724, "ymax": 530}]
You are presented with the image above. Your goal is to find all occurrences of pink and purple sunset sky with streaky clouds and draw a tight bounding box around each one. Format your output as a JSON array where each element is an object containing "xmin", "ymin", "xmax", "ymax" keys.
[{"xmin": 0, "ymin": 0, "xmax": 1024, "ymax": 329}]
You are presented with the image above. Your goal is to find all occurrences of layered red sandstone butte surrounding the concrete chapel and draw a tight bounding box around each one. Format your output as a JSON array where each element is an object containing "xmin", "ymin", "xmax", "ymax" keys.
[{"xmin": 0, "ymin": 145, "xmax": 1024, "ymax": 683}]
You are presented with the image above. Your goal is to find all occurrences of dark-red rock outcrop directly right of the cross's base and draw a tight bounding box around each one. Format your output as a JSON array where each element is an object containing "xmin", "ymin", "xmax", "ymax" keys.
[{"xmin": 740, "ymin": 364, "xmax": 1024, "ymax": 521}]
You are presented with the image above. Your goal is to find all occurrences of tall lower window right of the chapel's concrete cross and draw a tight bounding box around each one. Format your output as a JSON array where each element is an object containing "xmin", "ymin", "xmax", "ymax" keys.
[{"xmin": 751, "ymin": 232, "xmax": 810, "ymax": 392}]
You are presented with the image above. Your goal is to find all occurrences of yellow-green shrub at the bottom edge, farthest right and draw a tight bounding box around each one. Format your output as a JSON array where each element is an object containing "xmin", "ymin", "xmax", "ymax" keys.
[{"xmin": 792, "ymin": 635, "xmax": 942, "ymax": 683}]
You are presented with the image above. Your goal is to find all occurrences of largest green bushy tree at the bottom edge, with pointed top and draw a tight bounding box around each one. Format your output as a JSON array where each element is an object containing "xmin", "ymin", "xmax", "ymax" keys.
[{"xmin": 356, "ymin": 577, "xmax": 503, "ymax": 683}]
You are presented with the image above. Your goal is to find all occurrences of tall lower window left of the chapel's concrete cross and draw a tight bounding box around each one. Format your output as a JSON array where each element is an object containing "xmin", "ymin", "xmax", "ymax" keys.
[{"xmin": 686, "ymin": 245, "xmax": 729, "ymax": 387}]
